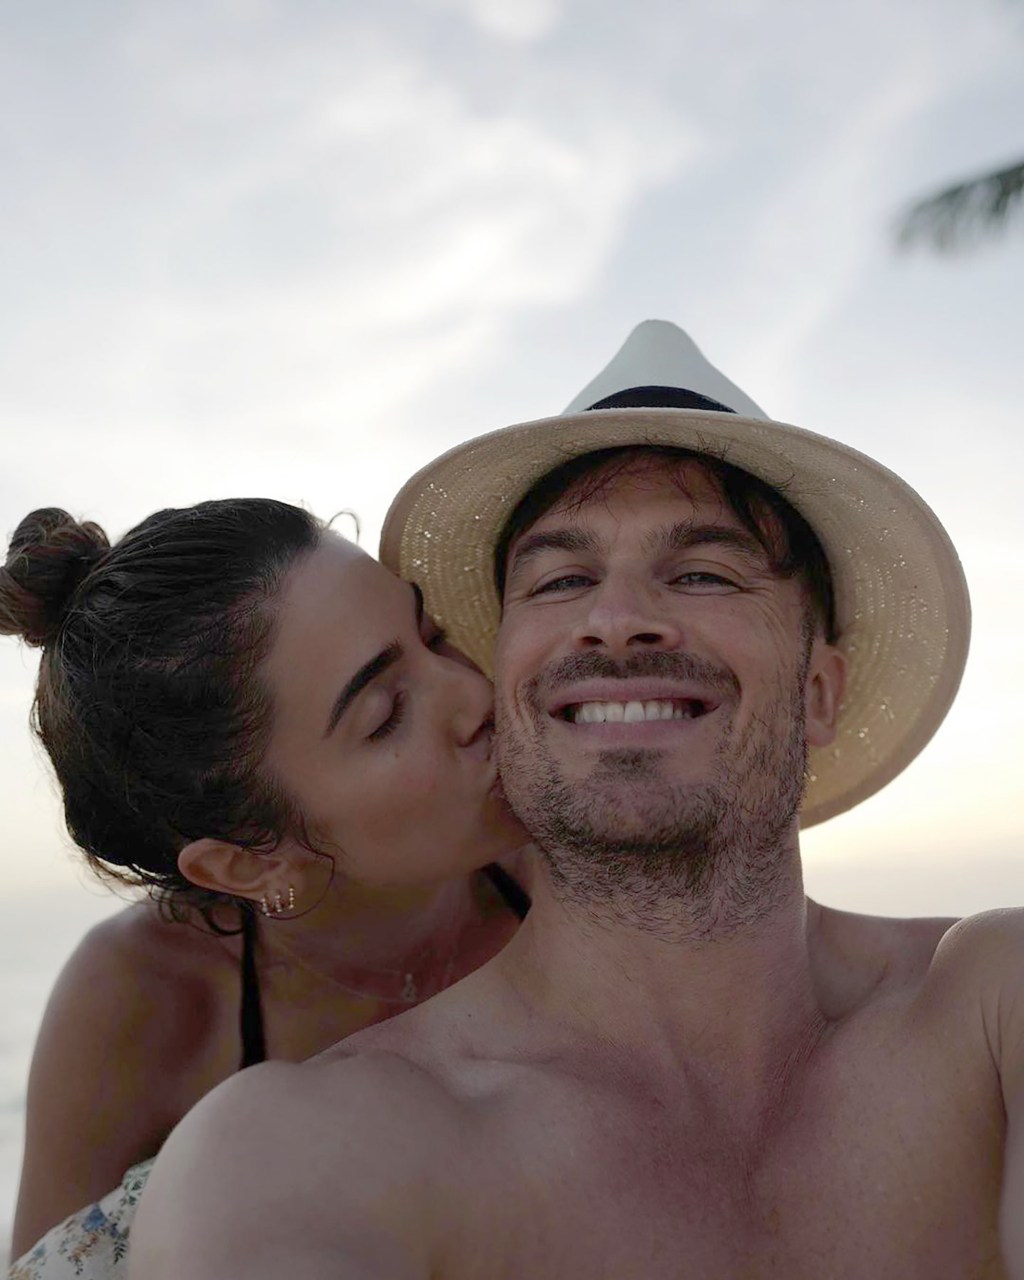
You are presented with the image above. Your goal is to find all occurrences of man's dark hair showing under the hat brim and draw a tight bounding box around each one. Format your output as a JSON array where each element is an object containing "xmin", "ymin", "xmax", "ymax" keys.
[{"xmin": 494, "ymin": 445, "xmax": 837, "ymax": 644}]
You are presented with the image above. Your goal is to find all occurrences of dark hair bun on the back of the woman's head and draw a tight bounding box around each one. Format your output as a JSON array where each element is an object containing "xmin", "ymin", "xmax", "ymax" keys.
[{"xmin": 0, "ymin": 507, "xmax": 110, "ymax": 645}]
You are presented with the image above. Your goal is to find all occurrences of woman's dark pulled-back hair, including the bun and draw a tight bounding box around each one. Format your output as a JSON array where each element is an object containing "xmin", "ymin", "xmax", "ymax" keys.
[{"xmin": 0, "ymin": 498, "xmax": 323, "ymax": 919}]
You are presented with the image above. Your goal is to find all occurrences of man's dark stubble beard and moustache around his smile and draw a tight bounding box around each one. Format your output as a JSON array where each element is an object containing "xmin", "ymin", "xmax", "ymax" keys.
[{"xmin": 497, "ymin": 648, "xmax": 809, "ymax": 938}]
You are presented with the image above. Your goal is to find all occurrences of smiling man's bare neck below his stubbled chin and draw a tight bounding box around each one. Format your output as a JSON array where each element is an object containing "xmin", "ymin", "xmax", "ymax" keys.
[{"xmin": 495, "ymin": 849, "xmax": 827, "ymax": 1102}]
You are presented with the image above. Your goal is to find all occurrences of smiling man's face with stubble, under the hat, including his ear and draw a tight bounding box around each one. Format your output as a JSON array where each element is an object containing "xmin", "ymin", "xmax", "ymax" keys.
[{"xmin": 497, "ymin": 460, "xmax": 841, "ymax": 911}]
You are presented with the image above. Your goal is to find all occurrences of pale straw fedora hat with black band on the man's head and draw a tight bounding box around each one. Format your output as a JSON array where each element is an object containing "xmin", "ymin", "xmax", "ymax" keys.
[{"xmin": 380, "ymin": 320, "xmax": 970, "ymax": 827}]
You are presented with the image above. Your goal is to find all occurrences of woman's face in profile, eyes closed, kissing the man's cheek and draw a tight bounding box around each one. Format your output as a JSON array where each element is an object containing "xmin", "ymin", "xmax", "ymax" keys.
[{"xmin": 262, "ymin": 532, "xmax": 527, "ymax": 887}]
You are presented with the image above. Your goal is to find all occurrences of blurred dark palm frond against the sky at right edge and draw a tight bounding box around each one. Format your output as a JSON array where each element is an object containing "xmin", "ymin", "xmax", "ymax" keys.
[{"xmin": 896, "ymin": 160, "xmax": 1024, "ymax": 253}]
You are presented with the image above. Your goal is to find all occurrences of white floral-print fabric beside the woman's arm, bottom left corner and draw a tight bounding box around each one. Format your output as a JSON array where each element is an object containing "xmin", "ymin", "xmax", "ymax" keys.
[{"xmin": 8, "ymin": 1160, "xmax": 154, "ymax": 1280}]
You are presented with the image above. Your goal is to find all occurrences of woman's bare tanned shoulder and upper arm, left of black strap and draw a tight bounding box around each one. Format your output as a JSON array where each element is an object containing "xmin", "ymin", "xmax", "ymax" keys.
[{"xmin": 15, "ymin": 902, "xmax": 238, "ymax": 1249}]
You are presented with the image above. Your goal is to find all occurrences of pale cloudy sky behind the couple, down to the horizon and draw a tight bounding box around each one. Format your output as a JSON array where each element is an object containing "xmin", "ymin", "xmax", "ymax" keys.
[{"xmin": 0, "ymin": 0, "xmax": 1024, "ymax": 914}]
